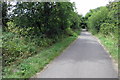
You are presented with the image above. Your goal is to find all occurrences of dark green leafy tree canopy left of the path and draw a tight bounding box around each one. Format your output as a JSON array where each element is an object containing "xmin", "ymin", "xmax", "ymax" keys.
[{"xmin": 9, "ymin": 2, "xmax": 79, "ymax": 38}]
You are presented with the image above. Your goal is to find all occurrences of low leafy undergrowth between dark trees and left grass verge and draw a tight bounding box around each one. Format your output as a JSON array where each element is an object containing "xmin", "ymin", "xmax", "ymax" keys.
[{"xmin": 2, "ymin": 32, "xmax": 59, "ymax": 66}]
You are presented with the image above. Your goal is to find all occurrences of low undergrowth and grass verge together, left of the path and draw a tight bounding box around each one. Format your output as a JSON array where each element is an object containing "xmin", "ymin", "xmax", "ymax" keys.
[{"xmin": 2, "ymin": 25, "xmax": 80, "ymax": 78}]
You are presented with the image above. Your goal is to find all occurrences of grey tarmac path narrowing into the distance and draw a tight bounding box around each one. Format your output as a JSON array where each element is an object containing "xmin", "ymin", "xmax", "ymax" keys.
[{"xmin": 36, "ymin": 31, "xmax": 118, "ymax": 78}]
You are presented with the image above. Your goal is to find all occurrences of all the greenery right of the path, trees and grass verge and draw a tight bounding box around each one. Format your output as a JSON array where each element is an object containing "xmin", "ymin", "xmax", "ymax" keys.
[{"xmin": 85, "ymin": 2, "xmax": 120, "ymax": 64}]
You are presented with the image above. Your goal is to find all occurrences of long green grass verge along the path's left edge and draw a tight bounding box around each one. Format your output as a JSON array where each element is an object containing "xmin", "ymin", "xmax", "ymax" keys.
[{"xmin": 3, "ymin": 36, "xmax": 77, "ymax": 78}]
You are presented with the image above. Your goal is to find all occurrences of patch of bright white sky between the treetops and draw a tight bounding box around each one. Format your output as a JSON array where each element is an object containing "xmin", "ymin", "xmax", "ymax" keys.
[{"xmin": 70, "ymin": 0, "xmax": 112, "ymax": 16}]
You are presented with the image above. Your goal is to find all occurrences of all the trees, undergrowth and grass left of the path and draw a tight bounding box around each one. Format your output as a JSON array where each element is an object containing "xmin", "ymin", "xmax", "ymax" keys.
[{"xmin": 2, "ymin": 2, "xmax": 82, "ymax": 78}]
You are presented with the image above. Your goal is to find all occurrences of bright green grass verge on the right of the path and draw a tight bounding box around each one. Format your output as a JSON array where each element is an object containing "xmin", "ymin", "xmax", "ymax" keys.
[{"xmin": 96, "ymin": 34, "xmax": 118, "ymax": 62}]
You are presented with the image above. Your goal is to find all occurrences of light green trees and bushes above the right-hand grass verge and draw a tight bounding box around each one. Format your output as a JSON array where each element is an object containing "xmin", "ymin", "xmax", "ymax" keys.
[{"xmin": 85, "ymin": 2, "xmax": 120, "ymax": 39}]
